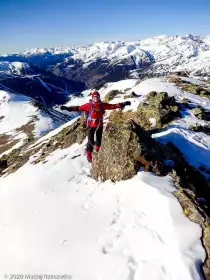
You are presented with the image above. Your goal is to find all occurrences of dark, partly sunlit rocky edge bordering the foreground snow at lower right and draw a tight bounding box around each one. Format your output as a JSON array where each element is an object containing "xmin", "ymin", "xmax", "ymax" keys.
[{"xmin": 163, "ymin": 143, "xmax": 210, "ymax": 280}]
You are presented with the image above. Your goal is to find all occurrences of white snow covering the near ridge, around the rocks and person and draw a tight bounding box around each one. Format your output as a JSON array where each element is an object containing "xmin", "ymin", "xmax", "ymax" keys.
[{"xmin": 0, "ymin": 78, "xmax": 210, "ymax": 280}]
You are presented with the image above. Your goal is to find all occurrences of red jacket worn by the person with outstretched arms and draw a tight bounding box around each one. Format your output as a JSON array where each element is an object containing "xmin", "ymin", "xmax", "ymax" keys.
[{"xmin": 72, "ymin": 102, "xmax": 121, "ymax": 127}]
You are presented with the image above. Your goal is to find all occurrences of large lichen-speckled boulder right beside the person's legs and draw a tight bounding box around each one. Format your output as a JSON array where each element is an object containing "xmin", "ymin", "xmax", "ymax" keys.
[{"xmin": 91, "ymin": 120, "xmax": 164, "ymax": 181}]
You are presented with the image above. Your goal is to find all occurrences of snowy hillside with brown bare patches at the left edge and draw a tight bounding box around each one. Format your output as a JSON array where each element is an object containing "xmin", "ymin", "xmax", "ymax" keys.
[{"xmin": 0, "ymin": 90, "xmax": 56, "ymax": 156}]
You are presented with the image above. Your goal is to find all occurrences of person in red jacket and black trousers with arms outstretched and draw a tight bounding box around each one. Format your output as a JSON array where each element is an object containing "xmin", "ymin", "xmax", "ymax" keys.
[{"xmin": 60, "ymin": 91, "xmax": 131, "ymax": 162}]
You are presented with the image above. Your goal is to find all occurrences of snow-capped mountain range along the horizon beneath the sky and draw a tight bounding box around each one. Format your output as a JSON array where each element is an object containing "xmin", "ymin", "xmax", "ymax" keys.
[{"xmin": 0, "ymin": 35, "xmax": 210, "ymax": 87}]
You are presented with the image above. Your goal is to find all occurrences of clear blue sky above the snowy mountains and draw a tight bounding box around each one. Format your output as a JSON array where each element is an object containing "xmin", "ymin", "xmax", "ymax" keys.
[{"xmin": 0, "ymin": 0, "xmax": 210, "ymax": 54}]
